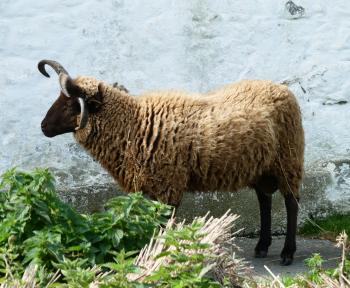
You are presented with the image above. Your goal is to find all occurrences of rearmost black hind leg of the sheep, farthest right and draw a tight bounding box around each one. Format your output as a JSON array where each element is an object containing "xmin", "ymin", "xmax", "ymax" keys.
[{"xmin": 281, "ymin": 194, "xmax": 298, "ymax": 266}]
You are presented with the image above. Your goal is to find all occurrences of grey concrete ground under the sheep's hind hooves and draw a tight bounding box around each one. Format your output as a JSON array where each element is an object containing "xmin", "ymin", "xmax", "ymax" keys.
[{"xmin": 235, "ymin": 237, "xmax": 341, "ymax": 277}]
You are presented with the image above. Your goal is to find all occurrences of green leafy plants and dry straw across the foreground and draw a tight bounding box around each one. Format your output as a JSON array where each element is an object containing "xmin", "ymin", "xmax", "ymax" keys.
[{"xmin": 0, "ymin": 169, "xmax": 350, "ymax": 288}]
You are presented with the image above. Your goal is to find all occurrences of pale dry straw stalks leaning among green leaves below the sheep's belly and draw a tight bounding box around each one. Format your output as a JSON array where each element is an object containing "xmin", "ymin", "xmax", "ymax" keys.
[{"xmin": 129, "ymin": 211, "xmax": 249, "ymax": 283}]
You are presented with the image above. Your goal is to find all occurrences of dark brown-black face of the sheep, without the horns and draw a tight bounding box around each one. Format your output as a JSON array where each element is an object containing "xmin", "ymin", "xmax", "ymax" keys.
[{"xmin": 41, "ymin": 93, "xmax": 80, "ymax": 137}]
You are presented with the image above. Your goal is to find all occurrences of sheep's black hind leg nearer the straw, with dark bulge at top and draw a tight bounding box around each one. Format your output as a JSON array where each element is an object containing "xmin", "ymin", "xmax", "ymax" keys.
[{"xmin": 255, "ymin": 176, "xmax": 277, "ymax": 258}]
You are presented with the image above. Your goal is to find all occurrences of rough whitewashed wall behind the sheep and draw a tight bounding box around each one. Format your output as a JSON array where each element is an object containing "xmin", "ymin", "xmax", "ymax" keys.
[{"xmin": 0, "ymin": 0, "xmax": 350, "ymax": 231}]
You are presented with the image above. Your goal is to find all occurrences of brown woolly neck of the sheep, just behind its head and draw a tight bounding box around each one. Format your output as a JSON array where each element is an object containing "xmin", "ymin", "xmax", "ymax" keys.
[{"xmin": 75, "ymin": 90, "xmax": 139, "ymax": 190}]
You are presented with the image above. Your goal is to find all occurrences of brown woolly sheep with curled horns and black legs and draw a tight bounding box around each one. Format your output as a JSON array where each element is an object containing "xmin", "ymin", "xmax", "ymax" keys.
[{"xmin": 38, "ymin": 60, "xmax": 304, "ymax": 265}]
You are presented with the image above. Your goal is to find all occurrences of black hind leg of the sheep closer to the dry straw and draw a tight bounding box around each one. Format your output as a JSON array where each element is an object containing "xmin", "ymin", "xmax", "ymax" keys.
[{"xmin": 255, "ymin": 188, "xmax": 272, "ymax": 258}]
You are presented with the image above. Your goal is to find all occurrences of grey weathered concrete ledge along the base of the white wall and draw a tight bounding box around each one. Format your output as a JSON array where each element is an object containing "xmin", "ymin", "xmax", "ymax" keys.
[{"xmin": 59, "ymin": 164, "xmax": 349, "ymax": 235}]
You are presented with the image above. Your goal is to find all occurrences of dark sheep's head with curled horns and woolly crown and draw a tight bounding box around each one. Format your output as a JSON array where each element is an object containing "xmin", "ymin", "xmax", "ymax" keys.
[{"xmin": 38, "ymin": 60, "xmax": 103, "ymax": 137}]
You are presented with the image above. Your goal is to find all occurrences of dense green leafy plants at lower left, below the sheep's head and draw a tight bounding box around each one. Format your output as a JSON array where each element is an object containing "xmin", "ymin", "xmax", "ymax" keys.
[{"xmin": 0, "ymin": 169, "xmax": 171, "ymax": 283}]
